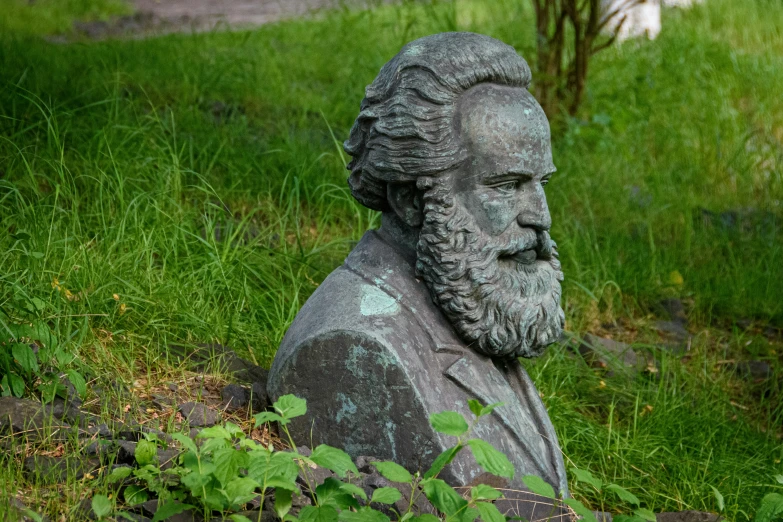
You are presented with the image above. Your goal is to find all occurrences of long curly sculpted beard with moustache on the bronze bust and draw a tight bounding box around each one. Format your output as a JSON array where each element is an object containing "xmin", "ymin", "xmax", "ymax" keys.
[{"xmin": 416, "ymin": 189, "xmax": 565, "ymax": 358}]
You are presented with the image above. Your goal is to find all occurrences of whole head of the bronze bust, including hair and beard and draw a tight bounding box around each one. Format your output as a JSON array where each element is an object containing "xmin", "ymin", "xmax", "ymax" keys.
[{"xmin": 345, "ymin": 33, "xmax": 564, "ymax": 357}]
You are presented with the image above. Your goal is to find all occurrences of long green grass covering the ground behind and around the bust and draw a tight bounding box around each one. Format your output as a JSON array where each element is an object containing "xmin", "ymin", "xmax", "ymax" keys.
[{"xmin": 0, "ymin": 0, "xmax": 783, "ymax": 520}]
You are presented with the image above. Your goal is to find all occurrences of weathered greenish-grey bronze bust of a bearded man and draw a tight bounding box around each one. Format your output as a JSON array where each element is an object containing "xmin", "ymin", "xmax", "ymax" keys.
[{"xmin": 269, "ymin": 33, "xmax": 567, "ymax": 493}]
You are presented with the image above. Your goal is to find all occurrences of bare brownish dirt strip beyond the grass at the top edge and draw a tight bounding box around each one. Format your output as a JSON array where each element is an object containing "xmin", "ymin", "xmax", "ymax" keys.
[{"xmin": 69, "ymin": 0, "xmax": 386, "ymax": 40}]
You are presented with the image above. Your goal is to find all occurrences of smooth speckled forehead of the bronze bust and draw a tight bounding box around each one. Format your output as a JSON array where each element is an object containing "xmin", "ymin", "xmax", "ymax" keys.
[{"xmin": 457, "ymin": 84, "xmax": 555, "ymax": 174}]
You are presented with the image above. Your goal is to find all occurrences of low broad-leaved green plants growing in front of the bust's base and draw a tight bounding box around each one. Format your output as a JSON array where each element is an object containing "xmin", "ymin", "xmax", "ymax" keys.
[{"xmin": 98, "ymin": 395, "xmax": 608, "ymax": 522}]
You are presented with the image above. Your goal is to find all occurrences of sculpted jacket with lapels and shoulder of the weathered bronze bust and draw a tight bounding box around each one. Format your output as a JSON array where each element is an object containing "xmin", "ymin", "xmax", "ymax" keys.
[{"xmin": 268, "ymin": 231, "xmax": 568, "ymax": 495}]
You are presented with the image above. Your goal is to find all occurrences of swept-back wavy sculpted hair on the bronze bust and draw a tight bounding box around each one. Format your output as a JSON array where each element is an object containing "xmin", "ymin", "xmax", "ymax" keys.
[{"xmin": 343, "ymin": 33, "xmax": 530, "ymax": 211}]
